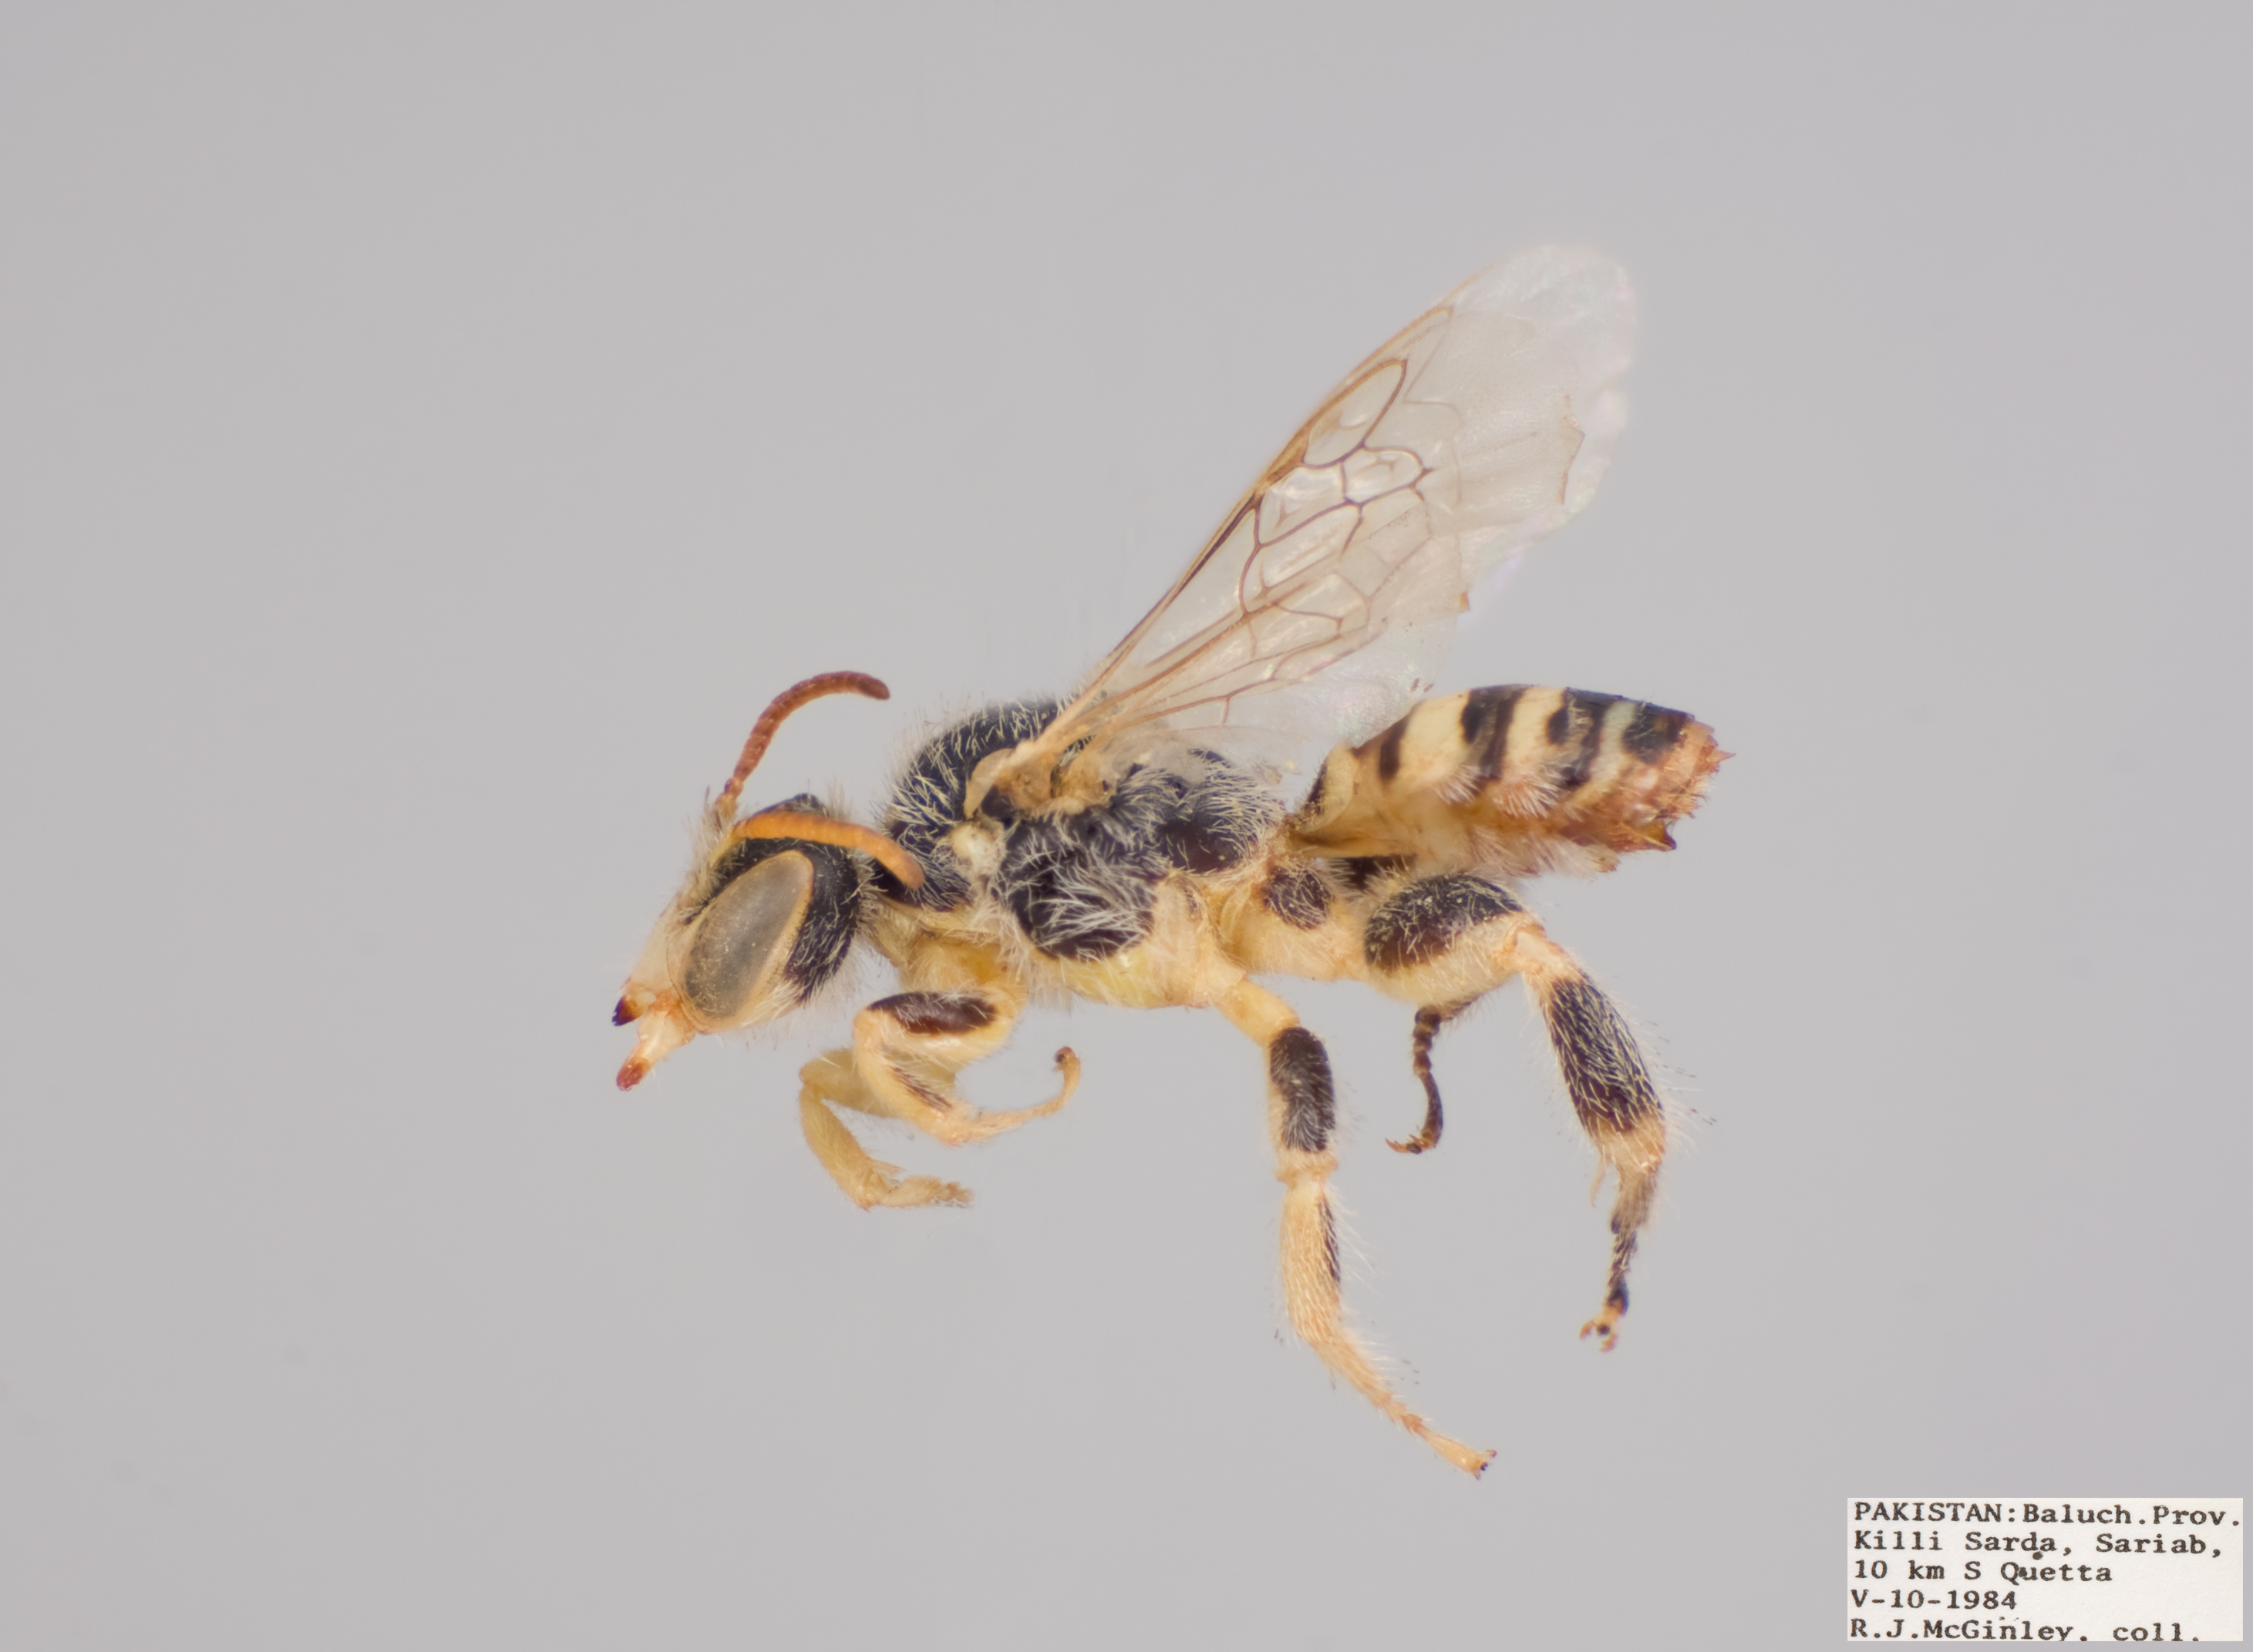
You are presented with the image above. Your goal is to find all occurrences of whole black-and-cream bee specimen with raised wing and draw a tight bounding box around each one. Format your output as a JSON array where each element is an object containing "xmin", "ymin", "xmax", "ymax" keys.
[{"xmin": 615, "ymin": 248, "xmax": 1726, "ymax": 1476}]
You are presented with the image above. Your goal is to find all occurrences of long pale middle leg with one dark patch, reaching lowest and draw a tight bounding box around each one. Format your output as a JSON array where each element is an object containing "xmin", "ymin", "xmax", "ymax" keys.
[{"xmin": 1221, "ymin": 981, "xmax": 1494, "ymax": 1476}]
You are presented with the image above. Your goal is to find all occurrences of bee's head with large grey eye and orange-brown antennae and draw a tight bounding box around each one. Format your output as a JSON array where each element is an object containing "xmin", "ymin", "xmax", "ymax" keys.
[{"xmin": 611, "ymin": 671, "xmax": 924, "ymax": 1088}]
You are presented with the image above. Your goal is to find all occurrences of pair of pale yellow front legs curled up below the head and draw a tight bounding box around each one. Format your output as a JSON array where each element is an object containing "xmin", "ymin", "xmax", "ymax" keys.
[{"xmin": 797, "ymin": 989, "xmax": 1079, "ymax": 1210}]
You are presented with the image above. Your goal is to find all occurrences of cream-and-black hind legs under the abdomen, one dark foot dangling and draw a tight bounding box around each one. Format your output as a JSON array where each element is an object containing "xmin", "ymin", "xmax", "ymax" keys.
[{"xmin": 1363, "ymin": 872, "xmax": 1667, "ymax": 1348}]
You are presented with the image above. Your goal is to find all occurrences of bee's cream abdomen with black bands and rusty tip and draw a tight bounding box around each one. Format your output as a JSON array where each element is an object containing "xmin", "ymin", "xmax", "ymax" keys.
[{"xmin": 1291, "ymin": 685, "xmax": 1728, "ymax": 874}]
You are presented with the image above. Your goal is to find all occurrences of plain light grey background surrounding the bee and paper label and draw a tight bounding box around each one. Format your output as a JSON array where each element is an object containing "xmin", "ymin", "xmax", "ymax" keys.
[{"xmin": 0, "ymin": 2, "xmax": 2253, "ymax": 1647}]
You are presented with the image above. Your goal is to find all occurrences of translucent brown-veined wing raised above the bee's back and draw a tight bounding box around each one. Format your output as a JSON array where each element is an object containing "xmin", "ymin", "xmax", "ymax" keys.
[{"xmin": 1036, "ymin": 248, "xmax": 1633, "ymax": 779}]
